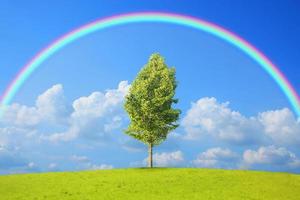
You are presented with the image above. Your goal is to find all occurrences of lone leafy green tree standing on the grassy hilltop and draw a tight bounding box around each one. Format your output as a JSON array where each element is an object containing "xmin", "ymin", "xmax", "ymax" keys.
[{"xmin": 124, "ymin": 53, "xmax": 181, "ymax": 167}]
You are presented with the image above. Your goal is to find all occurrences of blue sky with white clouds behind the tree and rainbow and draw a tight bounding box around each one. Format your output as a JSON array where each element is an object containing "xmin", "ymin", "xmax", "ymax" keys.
[{"xmin": 0, "ymin": 1, "xmax": 300, "ymax": 173}]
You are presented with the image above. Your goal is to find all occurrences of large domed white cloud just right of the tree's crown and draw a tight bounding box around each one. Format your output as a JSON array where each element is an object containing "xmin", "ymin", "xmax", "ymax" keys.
[{"xmin": 182, "ymin": 97, "xmax": 261, "ymax": 144}]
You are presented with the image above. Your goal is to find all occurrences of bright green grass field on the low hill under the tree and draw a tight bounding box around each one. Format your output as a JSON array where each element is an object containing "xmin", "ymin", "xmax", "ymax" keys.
[{"xmin": 0, "ymin": 168, "xmax": 300, "ymax": 200}]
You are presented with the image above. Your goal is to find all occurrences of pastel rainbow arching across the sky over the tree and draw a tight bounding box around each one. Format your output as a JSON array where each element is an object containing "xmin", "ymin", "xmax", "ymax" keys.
[{"xmin": 0, "ymin": 12, "xmax": 300, "ymax": 117}]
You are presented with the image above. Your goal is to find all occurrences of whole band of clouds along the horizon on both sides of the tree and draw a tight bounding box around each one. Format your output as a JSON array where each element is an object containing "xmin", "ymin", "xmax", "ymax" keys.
[{"xmin": 0, "ymin": 84, "xmax": 300, "ymax": 173}]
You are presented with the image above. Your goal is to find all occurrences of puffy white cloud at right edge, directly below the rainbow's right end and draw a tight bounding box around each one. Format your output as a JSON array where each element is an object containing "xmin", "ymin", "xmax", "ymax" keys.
[{"xmin": 258, "ymin": 108, "xmax": 300, "ymax": 145}]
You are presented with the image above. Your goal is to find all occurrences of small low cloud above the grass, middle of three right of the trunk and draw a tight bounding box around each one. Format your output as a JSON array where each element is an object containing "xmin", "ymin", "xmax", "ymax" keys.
[{"xmin": 192, "ymin": 147, "xmax": 240, "ymax": 168}]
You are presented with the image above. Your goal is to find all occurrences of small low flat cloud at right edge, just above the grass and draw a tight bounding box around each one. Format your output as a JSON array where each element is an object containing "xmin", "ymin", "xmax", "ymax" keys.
[{"xmin": 243, "ymin": 145, "xmax": 300, "ymax": 169}]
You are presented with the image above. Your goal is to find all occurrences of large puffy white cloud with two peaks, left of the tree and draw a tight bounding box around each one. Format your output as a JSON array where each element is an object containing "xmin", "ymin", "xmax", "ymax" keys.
[{"xmin": 1, "ymin": 81, "xmax": 130, "ymax": 142}]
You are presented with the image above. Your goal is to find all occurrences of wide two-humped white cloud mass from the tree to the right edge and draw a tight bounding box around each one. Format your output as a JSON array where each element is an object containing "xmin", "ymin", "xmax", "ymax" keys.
[{"xmin": 181, "ymin": 97, "xmax": 300, "ymax": 145}]
